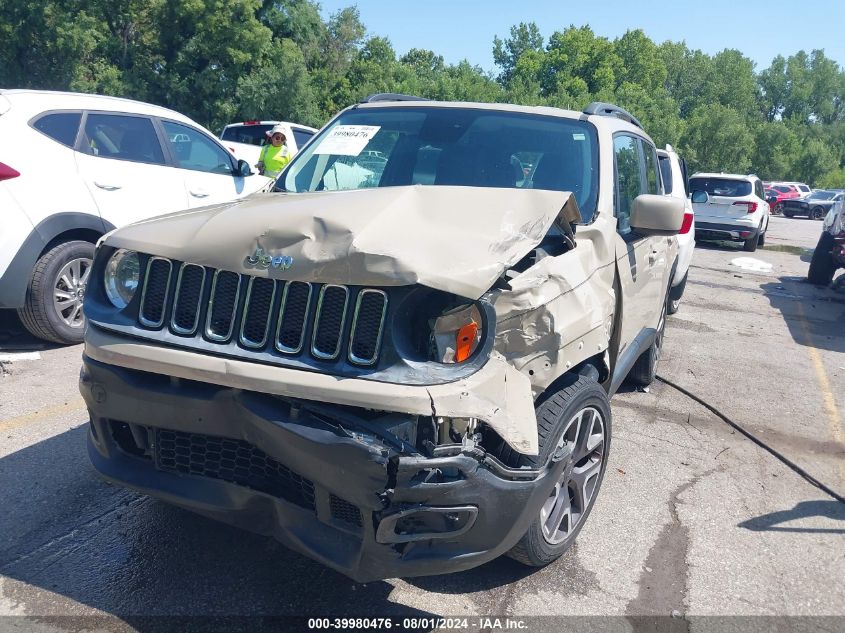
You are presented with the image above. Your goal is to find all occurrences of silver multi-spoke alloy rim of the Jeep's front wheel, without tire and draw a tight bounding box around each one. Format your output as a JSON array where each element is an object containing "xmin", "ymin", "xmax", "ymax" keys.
[{"xmin": 540, "ymin": 407, "xmax": 605, "ymax": 545}]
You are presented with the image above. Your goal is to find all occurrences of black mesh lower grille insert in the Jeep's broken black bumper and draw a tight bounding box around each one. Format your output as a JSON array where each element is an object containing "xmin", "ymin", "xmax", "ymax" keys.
[{"xmin": 154, "ymin": 429, "xmax": 314, "ymax": 510}]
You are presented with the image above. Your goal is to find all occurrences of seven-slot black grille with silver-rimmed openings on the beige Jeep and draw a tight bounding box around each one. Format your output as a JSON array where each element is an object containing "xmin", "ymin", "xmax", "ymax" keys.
[{"xmin": 138, "ymin": 257, "xmax": 388, "ymax": 366}]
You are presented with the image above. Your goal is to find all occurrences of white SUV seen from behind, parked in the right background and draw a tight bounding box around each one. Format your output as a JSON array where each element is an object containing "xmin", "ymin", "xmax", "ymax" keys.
[{"xmin": 689, "ymin": 173, "xmax": 769, "ymax": 253}]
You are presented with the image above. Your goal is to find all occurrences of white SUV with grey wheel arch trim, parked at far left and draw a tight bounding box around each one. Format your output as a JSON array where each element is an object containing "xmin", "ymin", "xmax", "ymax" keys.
[{"xmin": 0, "ymin": 90, "xmax": 270, "ymax": 343}]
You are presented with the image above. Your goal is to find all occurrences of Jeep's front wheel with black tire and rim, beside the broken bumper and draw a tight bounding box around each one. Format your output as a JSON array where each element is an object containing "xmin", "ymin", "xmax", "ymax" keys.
[{"xmin": 507, "ymin": 376, "xmax": 611, "ymax": 567}]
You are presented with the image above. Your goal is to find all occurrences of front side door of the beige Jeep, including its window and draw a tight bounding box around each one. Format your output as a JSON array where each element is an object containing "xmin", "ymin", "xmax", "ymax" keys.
[{"xmin": 613, "ymin": 133, "xmax": 667, "ymax": 355}]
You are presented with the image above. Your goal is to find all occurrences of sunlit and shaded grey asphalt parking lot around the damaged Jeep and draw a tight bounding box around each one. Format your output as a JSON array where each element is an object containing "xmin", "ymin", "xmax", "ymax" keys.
[{"xmin": 0, "ymin": 217, "xmax": 845, "ymax": 630}]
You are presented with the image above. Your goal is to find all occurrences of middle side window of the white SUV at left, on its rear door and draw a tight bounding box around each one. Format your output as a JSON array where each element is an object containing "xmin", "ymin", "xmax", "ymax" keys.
[{"xmin": 85, "ymin": 114, "xmax": 164, "ymax": 165}]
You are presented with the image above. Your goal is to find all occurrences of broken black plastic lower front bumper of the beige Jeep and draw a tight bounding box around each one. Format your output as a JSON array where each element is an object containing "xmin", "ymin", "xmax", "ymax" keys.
[{"xmin": 80, "ymin": 356, "xmax": 571, "ymax": 582}]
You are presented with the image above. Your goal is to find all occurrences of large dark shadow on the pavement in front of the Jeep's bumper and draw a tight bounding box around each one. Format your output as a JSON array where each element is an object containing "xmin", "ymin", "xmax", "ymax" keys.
[{"xmin": 0, "ymin": 425, "xmax": 438, "ymax": 616}]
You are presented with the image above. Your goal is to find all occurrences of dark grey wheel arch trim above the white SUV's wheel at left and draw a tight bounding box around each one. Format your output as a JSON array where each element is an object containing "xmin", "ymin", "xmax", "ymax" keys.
[{"xmin": 0, "ymin": 211, "xmax": 115, "ymax": 308}]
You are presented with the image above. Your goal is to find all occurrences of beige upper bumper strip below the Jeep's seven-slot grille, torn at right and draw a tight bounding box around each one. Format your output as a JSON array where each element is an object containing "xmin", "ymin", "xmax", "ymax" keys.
[{"xmin": 85, "ymin": 322, "xmax": 538, "ymax": 455}]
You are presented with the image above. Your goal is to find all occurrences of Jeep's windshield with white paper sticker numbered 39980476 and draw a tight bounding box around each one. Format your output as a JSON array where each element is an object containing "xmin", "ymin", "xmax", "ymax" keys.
[{"xmin": 278, "ymin": 106, "xmax": 598, "ymax": 221}]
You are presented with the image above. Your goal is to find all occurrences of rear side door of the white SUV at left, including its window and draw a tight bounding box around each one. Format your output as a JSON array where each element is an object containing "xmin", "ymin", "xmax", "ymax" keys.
[{"xmin": 75, "ymin": 112, "xmax": 187, "ymax": 226}]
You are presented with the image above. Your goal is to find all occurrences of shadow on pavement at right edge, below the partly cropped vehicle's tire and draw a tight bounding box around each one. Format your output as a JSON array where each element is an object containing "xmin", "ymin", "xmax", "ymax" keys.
[{"xmin": 760, "ymin": 277, "xmax": 845, "ymax": 353}]
